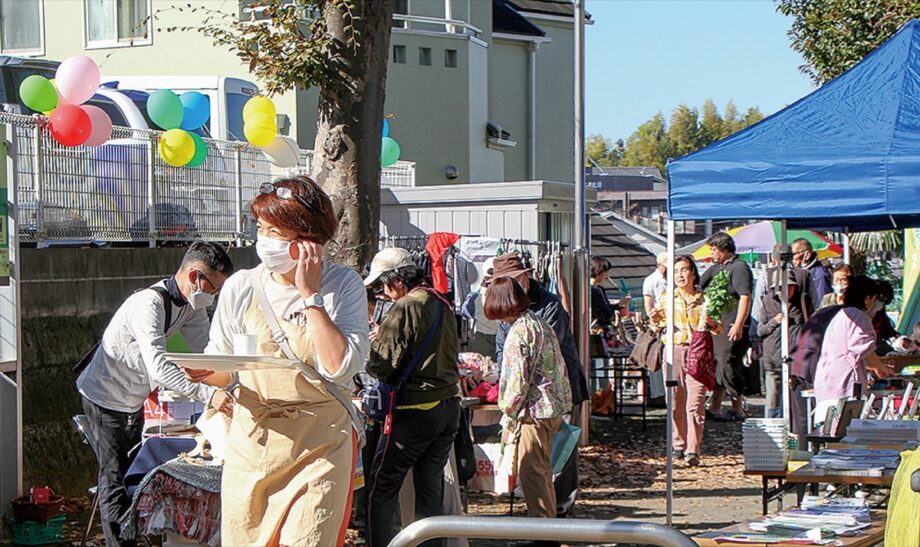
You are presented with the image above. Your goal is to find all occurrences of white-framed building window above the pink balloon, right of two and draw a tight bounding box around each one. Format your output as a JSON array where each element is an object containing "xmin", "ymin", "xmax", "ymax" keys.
[{"xmin": 84, "ymin": 0, "xmax": 151, "ymax": 47}]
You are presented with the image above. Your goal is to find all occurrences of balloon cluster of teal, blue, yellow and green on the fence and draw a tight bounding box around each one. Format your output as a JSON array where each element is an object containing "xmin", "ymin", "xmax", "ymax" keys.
[{"xmin": 147, "ymin": 89, "xmax": 211, "ymax": 167}]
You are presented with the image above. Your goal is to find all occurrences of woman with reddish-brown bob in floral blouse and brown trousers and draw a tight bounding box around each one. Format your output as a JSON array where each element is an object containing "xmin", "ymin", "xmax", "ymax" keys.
[{"xmin": 484, "ymin": 277, "xmax": 572, "ymax": 518}]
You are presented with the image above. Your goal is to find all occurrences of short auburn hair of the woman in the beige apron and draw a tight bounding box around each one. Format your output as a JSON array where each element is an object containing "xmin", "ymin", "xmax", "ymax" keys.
[{"xmin": 250, "ymin": 175, "xmax": 339, "ymax": 245}]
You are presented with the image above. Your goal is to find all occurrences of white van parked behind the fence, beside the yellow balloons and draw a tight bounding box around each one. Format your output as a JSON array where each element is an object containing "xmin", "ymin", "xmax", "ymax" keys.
[{"xmin": 103, "ymin": 76, "xmax": 259, "ymax": 142}]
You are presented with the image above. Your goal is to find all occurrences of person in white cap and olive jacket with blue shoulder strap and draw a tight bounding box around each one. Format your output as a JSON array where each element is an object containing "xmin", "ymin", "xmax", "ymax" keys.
[{"xmin": 364, "ymin": 247, "xmax": 460, "ymax": 547}]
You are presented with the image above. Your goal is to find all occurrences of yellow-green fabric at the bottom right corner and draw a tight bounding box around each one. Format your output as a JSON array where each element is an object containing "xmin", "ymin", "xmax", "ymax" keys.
[{"xmin": 885, "ymin": 449, "xmax": 920, "ymax": 547}]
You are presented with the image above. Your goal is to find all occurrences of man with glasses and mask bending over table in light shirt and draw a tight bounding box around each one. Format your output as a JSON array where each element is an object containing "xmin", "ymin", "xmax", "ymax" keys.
[{"xmin": 77, "ymin": 241, "xmax": 233, "ymax": 546}]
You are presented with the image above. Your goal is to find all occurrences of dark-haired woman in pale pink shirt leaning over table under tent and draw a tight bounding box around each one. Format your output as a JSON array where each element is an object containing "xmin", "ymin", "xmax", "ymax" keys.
[{"xmin": 815, "ymin": 272, "xmax": 893, "ymax": 423}]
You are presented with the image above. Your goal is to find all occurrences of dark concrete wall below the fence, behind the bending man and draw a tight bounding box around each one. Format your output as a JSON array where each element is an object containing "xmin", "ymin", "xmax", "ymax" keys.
[{"xmin": 22, "ymin": 248, "xmax": 256, "ymax": 495}]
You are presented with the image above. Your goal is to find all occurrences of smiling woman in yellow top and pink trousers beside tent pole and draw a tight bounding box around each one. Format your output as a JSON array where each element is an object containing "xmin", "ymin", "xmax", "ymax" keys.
[{"xmin": 650, "ymin": 255, "xmax": 722, "ymax": 467}]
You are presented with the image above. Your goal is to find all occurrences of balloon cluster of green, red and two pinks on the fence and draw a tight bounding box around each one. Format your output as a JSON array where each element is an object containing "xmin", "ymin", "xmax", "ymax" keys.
[{"xmin": 19, "ymin": 55, "xmax": 112, "ymax": 146}]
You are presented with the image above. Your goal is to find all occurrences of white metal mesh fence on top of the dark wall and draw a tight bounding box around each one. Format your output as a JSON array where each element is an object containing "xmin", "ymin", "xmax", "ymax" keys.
[{"xmin": 0, "ymin": 113, "xmax": 415, "ymax": 246}]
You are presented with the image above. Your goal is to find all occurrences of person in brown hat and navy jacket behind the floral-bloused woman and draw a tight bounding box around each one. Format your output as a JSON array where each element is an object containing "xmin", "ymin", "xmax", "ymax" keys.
[{"xmin": 486, "ymin": 253, "xmax": 589, "ymax": 516}]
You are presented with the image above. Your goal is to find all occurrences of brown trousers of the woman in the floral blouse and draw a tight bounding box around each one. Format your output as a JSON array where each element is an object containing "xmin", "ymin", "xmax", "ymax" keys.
[{"xmin": 509, "ymin": 416, "xmax": 562, "ymax": 518}]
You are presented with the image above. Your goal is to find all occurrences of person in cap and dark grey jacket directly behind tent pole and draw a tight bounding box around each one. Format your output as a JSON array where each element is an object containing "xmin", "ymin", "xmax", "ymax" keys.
[{"xmin": 757, "ymin": 270, "xmax": 807, "ymax": 418}]
